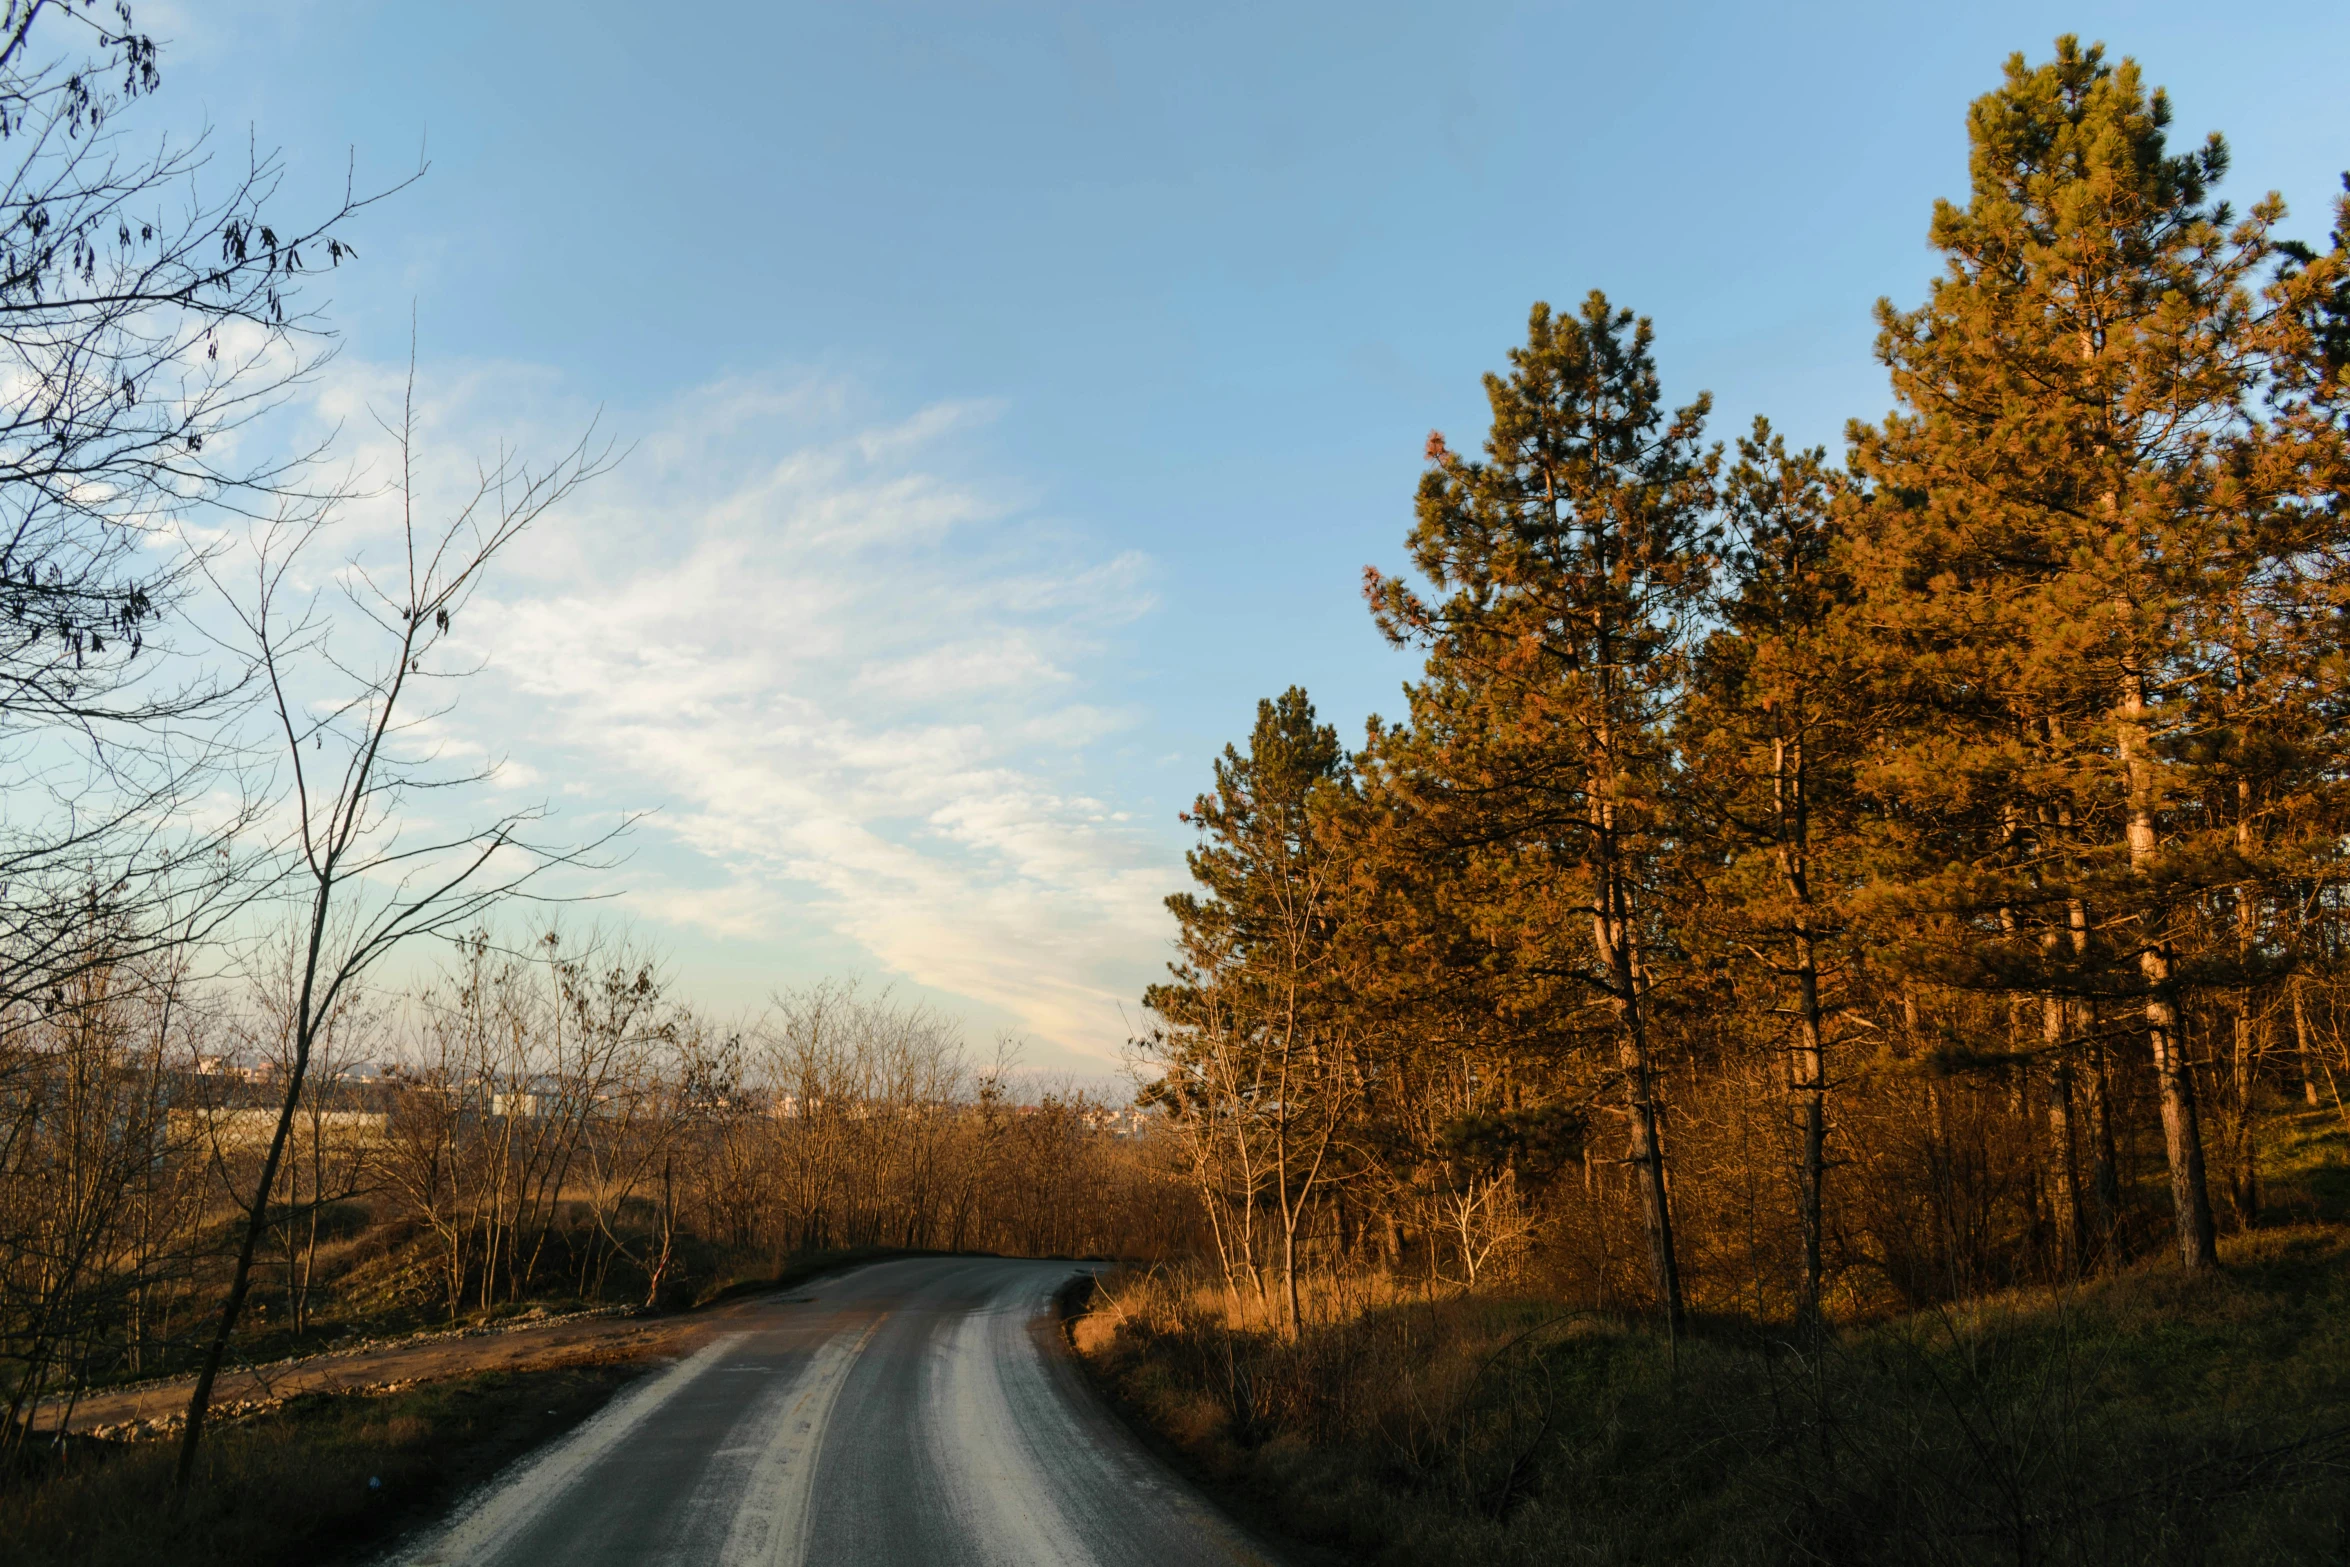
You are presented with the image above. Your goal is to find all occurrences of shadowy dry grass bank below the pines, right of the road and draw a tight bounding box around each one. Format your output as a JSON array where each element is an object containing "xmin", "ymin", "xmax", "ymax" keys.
[{"xmin": 1076, "ymin": 1224, "xmax": 2350, "ymax": 1567}]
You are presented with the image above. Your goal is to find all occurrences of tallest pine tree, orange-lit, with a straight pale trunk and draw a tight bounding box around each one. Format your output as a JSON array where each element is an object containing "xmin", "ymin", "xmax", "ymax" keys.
[{"xmin": 1852, "ymin": 38, "xmax": 2277, "ymax": 1266}]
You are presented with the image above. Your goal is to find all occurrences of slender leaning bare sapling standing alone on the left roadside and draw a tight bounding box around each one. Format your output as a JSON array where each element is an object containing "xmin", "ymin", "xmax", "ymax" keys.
[{"xmin": 176, "ymin": 369, "xmax": 611, "ymax": 1492}]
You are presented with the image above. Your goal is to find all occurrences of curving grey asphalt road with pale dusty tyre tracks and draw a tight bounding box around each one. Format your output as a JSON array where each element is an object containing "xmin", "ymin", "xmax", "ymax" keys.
[{"xmin": 392, "ymin": 1257, "xmax": 1267, "ymax": 1567}]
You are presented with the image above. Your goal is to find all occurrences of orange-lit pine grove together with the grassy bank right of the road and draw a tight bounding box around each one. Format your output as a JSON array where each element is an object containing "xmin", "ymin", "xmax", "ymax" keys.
[{"xmin": 1109, "ymin": 38, "xmax": 2350, "ymax": 1562}]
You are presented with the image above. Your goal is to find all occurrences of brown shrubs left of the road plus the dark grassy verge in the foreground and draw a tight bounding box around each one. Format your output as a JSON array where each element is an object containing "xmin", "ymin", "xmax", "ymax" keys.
[{"xmin": 0, "ymin": 958, "xmax": 1175, "ymax": 1565}]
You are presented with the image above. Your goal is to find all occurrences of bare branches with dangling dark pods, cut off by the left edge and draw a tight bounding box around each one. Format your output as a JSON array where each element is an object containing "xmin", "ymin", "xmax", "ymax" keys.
[{"xmin": 0, "ymin": 0, "xmax": 421, "ymax": 1043}]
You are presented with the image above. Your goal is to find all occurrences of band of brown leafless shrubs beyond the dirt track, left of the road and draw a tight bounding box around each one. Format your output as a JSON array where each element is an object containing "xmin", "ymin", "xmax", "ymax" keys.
[{"xmin": 0, "ymin": 967, "xmax": 1175, "ymax": 1484}]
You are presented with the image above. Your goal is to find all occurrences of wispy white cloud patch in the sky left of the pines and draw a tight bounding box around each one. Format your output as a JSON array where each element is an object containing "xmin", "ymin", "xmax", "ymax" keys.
[{"xmin": 352, "ymin": 371, "xmax": 1193, "ymax": 1057}]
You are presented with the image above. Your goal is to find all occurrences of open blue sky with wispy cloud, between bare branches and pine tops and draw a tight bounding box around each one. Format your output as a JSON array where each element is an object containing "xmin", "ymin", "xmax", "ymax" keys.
[{"xmin": 139, "ymin": 0, "xmax": 2350, "ymax": 1067}]
